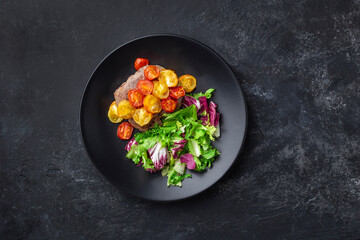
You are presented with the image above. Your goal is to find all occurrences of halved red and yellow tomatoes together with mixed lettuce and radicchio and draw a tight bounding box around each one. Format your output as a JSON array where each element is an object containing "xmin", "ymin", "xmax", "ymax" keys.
[{"xmin": 108, "ymin": 58, "xmax": 220, "ymax": 187}]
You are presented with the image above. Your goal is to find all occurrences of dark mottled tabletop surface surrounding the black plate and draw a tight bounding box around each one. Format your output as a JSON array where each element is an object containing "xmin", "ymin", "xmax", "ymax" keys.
[{"xmin": 0, "ymin": 0, "xmax": 360, "ymax": 239}]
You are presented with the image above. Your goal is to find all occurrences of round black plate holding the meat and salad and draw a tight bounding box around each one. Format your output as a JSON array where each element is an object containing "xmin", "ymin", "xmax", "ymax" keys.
[{"xmin": 80, "ymin": 35, "xmax": 247, "ymax": 201}]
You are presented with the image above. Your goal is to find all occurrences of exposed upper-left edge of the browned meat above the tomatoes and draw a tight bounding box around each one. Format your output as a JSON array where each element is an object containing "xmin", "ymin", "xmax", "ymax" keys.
[{"xmin": 114, "ymin": 65, "xmax": 164, "ymax": 104}]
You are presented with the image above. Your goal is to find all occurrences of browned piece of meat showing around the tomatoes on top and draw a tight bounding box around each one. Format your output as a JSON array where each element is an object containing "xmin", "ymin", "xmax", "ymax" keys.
[{"xmin": 114, "ymin": 65, "xmax": 182, "ymax": 132}]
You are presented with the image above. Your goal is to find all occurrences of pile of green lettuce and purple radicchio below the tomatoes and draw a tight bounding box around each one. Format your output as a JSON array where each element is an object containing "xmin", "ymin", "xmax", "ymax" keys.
[{"xmin": 127, "ymin": 89, "xmax": 220, "ymax": 187}]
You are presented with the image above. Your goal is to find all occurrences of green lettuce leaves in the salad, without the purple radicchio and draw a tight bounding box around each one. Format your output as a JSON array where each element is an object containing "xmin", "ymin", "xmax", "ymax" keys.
[{"xmin": 126, "ymin": 89, "xmax": 220, "ymax": 187}]
